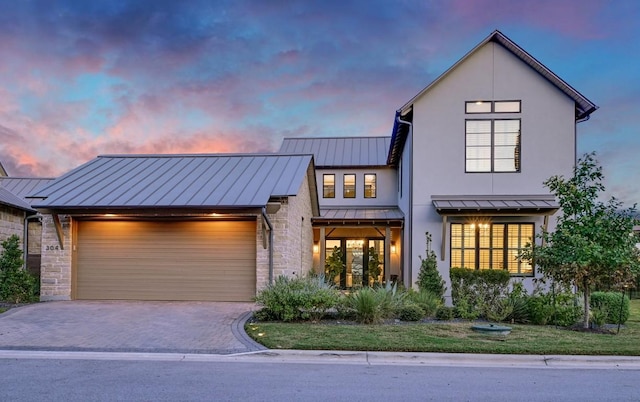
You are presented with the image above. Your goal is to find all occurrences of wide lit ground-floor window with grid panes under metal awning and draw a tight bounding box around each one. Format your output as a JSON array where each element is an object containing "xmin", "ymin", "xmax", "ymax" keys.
[{"xmin": 451, "ymin": 223, "xmax": 534, "ymax": 276}]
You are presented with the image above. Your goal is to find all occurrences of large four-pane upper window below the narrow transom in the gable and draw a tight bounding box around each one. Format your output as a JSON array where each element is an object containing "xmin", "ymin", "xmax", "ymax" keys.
[{"xmin": 465, "ymin": 119, "xmax": 520, "ymax": 172}]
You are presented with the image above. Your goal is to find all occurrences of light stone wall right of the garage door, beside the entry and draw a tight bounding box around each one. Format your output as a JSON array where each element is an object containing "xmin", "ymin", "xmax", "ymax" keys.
[{"xmin": 256, "ymin": 174, "xmax": 313, "ymax": 290}]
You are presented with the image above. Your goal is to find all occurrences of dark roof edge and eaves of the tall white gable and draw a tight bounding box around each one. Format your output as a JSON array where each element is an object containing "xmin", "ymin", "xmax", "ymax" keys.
[{"xmin": 387, "ymin": 30, "xmax": 598, "ymax": 164}]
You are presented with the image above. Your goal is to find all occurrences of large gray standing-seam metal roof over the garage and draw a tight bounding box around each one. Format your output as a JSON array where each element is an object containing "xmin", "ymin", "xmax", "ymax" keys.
[{"xmin": 32, "ymin": 154, "xmax": 317, "ymax": 210}]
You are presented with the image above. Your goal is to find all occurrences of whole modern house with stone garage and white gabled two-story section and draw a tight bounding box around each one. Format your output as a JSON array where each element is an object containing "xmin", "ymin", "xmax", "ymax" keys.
[{"xmin": 34, "ymin": 31, "xmax": 597, "ymax": 301}]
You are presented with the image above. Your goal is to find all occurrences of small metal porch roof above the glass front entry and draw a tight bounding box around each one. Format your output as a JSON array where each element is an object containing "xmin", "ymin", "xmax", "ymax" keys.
[{"xmin": 313, "ymin": 207, "xmax": 404, "ymax": 227}]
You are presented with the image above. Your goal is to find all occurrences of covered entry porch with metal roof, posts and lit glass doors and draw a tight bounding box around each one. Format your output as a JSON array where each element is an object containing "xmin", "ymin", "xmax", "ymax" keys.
[{"xmin": 313, "ymin": 208, "xmax": 404, "ymax": 289}]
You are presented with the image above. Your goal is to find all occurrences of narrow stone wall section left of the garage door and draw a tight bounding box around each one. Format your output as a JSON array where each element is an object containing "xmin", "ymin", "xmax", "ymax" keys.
[{"xmin": 40, "ymin": 215, "xmax": 73, "ymax": 301}]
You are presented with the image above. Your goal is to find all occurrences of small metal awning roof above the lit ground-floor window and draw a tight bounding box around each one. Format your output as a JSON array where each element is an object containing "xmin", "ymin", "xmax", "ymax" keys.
[{"xmin": 431, "ymin": 194, "xmax": 560, "ymax": 213}]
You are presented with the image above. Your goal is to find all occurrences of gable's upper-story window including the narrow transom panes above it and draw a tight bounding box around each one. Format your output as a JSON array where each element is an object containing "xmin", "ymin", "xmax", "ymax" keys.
[{"xmin": 465, "ymin": 101, "xmax": 521, "ymax": 172}]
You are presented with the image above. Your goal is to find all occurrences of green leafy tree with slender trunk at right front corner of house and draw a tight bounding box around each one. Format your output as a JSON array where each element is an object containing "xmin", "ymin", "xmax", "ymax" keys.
[{"xmin": 520, "ymin": 153, "xmax": 639, "ymax": 328}]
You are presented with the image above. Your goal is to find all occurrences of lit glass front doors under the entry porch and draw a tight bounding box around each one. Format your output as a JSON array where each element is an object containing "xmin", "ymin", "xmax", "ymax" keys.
[{"xmin": 325, "ymin": 239, "xmax": 385, "ymax": 289}]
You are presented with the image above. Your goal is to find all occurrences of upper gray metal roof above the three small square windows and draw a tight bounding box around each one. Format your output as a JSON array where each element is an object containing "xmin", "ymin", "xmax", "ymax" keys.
[{"xmin": 278, "ymin": 137, "xmax": 391, "ymax": 167}]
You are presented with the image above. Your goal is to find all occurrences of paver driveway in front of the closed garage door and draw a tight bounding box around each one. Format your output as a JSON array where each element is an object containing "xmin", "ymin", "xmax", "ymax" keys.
[{"xmin": 0, "ymin": 301, "xmax": 261, "ymax": 354}]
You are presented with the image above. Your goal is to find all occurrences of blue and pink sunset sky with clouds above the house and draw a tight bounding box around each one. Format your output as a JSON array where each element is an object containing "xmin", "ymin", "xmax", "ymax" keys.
[{"xmin": 0, "ymin": 0, "xmax": 640, "ymax": 206}]
